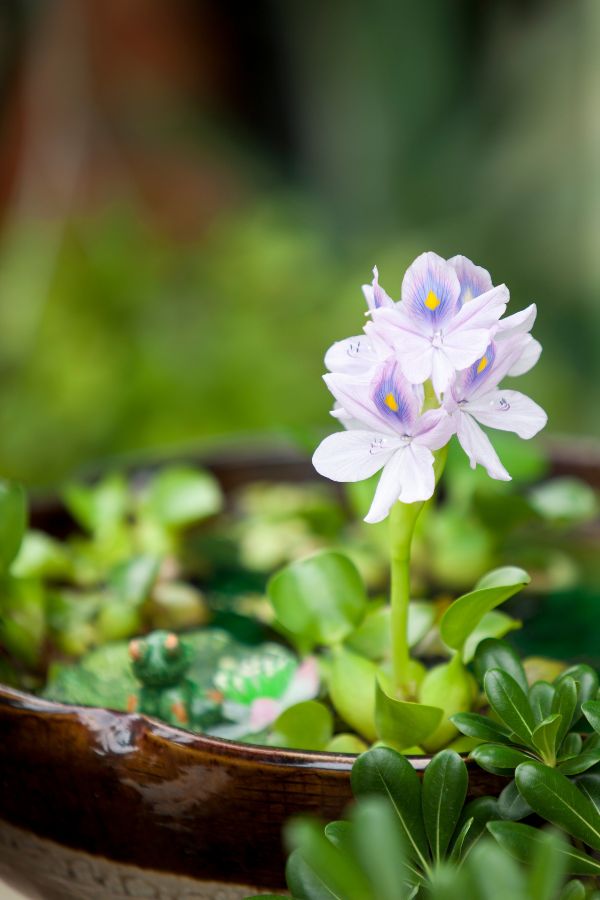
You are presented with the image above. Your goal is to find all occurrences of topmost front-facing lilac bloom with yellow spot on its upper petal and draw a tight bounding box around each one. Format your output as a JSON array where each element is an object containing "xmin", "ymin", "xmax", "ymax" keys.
[{"xmin": 372, "ymin": 252, "xmax": 509, "ymax": 397}]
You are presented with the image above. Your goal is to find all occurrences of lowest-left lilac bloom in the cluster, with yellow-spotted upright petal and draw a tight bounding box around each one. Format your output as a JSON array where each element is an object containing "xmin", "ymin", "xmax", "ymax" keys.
[{"xmin": 313, "ymin": 360, "xmax": 453, "ymax": 522}]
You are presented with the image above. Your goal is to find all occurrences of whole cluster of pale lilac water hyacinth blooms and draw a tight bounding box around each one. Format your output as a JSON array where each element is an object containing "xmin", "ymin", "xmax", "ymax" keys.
[{"xmin": 313, "ymin": 252, "xmax": 547, "ymax": 522}]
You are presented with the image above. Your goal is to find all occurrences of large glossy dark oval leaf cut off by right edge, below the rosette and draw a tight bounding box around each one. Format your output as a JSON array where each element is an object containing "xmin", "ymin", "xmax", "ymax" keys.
[{"xmin": 515, "ymin": 762, "xmax": 600, "ymax": 850}]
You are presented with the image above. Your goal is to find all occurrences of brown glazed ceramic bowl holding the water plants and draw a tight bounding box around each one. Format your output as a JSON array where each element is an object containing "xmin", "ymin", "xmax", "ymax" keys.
[{"xmin": 0, "ymin": 444, "xmax": 600, "ymax": 900}]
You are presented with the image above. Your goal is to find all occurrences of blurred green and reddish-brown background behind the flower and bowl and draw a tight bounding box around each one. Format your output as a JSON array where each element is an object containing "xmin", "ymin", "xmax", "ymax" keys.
[{"xmin": 0, "ymin": 0, "xmax": 600, "ymax": 485}]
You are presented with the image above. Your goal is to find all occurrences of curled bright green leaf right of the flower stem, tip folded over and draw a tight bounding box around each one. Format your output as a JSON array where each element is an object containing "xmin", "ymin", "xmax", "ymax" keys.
[{"xmin": 440, "ymin": 566, "xmax": 531, "ymax": 650}]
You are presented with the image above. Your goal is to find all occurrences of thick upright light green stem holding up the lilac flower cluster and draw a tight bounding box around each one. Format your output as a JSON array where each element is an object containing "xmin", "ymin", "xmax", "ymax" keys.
[{"xmin": 390, "ymin": 448, "xmax": 447, "ymax": 696}]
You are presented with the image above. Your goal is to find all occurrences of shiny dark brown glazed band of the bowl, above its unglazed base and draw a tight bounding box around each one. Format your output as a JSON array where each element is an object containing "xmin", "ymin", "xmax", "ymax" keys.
[{"xmin": 0, "ymin": 688, "xmax": 505, "ymax": 888}]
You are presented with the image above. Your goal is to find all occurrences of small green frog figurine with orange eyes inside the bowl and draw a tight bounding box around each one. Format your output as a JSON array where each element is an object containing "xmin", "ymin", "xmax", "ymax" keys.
[{"xmin": 128, "ymin": 631, "xmax": 222, "ymax": 731}]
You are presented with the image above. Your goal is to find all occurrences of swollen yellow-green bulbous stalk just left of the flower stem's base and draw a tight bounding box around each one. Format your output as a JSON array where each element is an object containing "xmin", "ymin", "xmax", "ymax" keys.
[{"xmin": 329, "ymin": 648, "xmax": 377, "ymax": 741}]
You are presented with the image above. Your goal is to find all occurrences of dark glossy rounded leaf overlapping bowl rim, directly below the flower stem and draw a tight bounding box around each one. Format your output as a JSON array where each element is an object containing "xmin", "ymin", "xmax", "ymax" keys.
[{"xmin": 351, "ymin": 747, "xmax": 429, "ymax": 870}]
